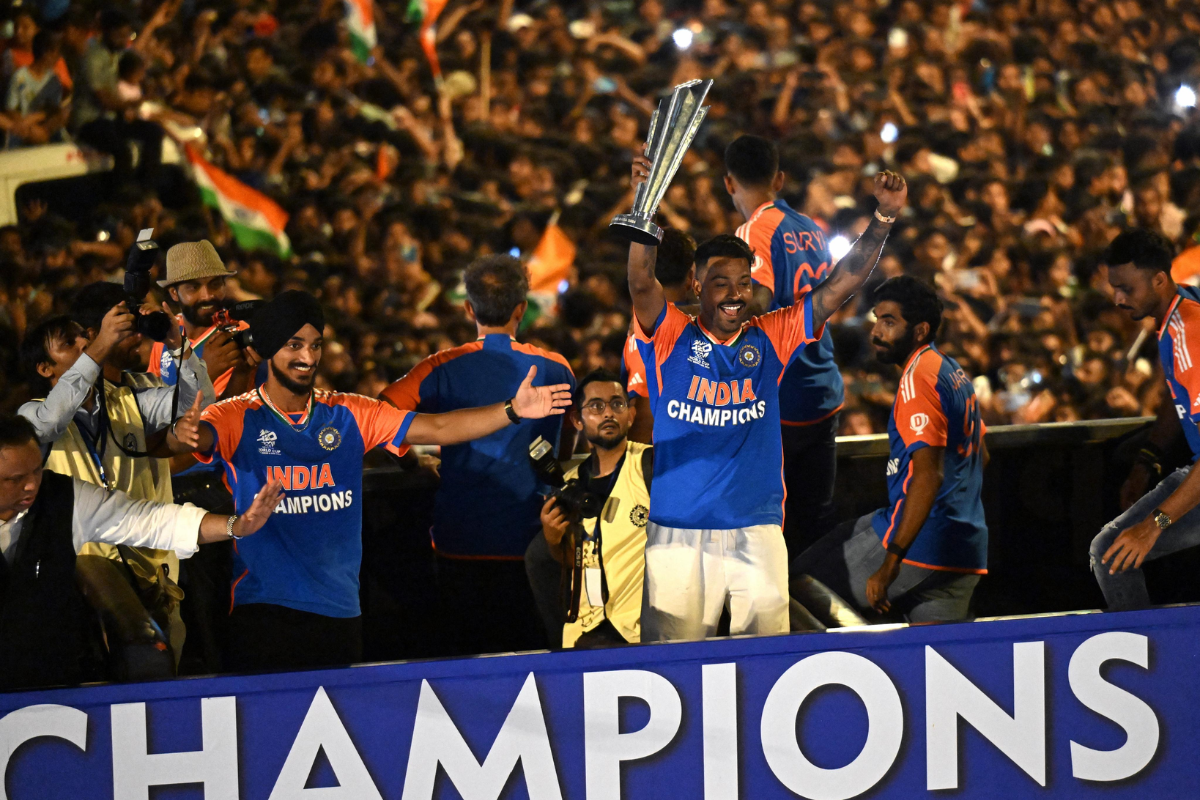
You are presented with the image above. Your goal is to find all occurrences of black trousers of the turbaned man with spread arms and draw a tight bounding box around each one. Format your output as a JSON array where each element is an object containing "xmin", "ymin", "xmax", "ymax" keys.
[{"xmin": 224, "ymin": 603, "xmax": 362, "ymax": 672}]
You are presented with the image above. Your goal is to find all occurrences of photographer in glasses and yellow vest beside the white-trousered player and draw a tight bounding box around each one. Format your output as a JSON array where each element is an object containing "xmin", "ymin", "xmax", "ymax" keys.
[{"xmin": 541, "ymin": 369, "xmax": 654, "ymax": 649}]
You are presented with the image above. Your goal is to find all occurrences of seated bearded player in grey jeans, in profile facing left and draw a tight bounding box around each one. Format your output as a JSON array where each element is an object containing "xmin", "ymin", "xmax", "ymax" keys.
[{"xmin": 792, "ymin": 276, "xmax": 988, "ymax": 622}]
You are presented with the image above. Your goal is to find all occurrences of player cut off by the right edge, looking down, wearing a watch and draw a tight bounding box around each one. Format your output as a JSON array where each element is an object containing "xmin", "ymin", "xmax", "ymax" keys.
[{"xmin": 1091, "ymin": 228, "xmax": 1200, "ymax": 610}]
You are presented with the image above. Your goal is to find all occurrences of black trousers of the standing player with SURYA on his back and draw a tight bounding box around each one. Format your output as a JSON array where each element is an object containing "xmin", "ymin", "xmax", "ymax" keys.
[{"xmin": 782, "ymin": 414, "xmax": 841, "ymax": 561}]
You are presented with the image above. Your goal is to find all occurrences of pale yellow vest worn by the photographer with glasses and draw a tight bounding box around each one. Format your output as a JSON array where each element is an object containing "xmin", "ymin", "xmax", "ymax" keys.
[{"xmin": 563, "ymin": 441, "xmax": 650, "ymax": 648}]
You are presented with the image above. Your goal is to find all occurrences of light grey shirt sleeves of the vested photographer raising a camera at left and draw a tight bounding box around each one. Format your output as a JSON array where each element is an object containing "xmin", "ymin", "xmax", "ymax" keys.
[{"xmin": 18, "ymin": 353, "xmax": 216, "ymax": 452}]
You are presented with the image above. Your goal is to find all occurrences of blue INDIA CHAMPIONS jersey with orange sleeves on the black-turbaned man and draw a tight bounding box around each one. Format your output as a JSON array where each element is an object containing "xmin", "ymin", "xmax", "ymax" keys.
[{"xmin": 197, "ymin": 389, "xmax": 414, "ymax": 618}]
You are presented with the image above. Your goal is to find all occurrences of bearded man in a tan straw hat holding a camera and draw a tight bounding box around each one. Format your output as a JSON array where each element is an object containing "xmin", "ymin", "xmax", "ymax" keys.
[{"xmin": 149, "ymin": 239, "xmax": 258, "ymax": 400}]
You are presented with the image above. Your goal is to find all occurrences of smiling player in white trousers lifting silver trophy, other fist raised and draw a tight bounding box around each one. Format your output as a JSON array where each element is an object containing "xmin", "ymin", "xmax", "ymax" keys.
[{"xmin": 612, "ymin": 80, "xmax": 907, "ymax": 642}]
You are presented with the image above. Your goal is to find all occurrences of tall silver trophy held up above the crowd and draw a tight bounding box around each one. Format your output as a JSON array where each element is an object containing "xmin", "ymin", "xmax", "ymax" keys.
[{"xmin": 608, "ymin": 80, "xmax": 713, "ymax": 247}]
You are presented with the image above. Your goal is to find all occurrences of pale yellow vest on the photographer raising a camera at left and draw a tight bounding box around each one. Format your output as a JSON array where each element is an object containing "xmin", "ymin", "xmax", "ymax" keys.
[{"xmin": 39, "ymin": 373, "xmax": 185, "ymax": 663}]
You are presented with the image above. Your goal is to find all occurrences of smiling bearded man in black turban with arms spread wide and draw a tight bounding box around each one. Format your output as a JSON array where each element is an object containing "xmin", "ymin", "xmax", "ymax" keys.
[{"xmin": 168, "ymin": 290, "xmax": 571, "ymax": 670}]
